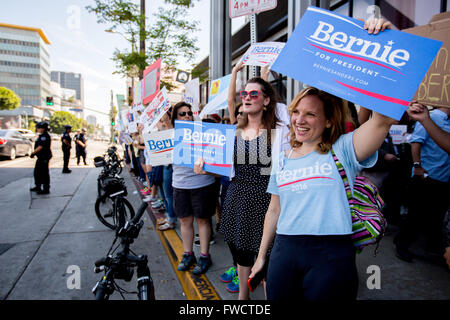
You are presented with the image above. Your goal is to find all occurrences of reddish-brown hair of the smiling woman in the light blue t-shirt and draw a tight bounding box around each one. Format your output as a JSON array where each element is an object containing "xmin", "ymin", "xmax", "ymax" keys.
[{"xmin": 289, "ymin": 87, "xmax": 346, "ymax": 154}]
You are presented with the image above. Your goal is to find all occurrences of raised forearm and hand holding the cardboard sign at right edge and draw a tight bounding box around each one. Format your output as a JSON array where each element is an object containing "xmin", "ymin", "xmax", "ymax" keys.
[{"xmin": 406, "ymin": 102, "xmax": 450, "ymax": 153}]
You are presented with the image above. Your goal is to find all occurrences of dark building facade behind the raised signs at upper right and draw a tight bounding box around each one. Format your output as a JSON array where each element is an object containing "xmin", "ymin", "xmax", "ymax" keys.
[{"xmin": 196, "ymin": 0, "xmax": 447, "ymax": 110}]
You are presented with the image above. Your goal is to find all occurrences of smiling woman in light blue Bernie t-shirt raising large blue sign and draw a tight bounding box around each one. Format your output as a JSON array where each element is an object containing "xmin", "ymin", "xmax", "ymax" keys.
[{"xmin": 250, "ymin": 19, "xmax": 395, "ymax": 300}]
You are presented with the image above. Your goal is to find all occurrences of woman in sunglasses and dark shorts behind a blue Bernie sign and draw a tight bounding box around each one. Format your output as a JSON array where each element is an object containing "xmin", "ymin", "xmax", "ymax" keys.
[{"xmin": 171, "ymin": 102, "xmax": 217, "ymax": 275}]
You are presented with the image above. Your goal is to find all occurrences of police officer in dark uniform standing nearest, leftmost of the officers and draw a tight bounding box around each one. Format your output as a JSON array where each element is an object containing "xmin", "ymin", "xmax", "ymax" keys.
[{"xmin": 30, "ymin": 122, "xmax": 52, "ymax": 194}]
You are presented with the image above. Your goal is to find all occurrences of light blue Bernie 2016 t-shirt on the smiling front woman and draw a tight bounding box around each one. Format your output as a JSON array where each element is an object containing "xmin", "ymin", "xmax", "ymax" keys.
[{"xmin": 267, "ymin": 132, "xmax": 377, "ymax": 235}]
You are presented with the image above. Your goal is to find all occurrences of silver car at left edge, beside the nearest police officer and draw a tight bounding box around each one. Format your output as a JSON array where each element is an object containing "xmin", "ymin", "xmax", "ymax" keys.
[{"xmin": 0, "ymin": 129, "xmax": 33, "ymax": 160}]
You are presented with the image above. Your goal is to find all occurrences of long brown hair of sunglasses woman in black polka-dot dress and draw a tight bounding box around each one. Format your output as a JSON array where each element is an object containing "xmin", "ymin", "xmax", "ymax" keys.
[{"xmin": 236, "ymin": 77, "xmax": 279, "ymax": 141}]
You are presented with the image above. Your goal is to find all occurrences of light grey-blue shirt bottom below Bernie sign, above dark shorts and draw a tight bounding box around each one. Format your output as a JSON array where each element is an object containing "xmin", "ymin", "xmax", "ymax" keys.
[{"xmin": 172, "ymin": 164, "xmax": 215, "ymax": 189}]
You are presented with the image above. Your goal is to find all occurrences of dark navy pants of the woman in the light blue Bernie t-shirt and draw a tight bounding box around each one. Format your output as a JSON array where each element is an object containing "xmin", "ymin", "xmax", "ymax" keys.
[{"xmin": 267, "ymin": 235, "xmax": 358, "ymax": 300}]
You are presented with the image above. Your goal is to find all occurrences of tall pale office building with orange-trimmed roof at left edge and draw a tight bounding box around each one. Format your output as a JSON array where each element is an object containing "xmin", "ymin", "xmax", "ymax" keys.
[{"xmin": 0, "ymin": 23, "xmax": 52, "ymax": 127}]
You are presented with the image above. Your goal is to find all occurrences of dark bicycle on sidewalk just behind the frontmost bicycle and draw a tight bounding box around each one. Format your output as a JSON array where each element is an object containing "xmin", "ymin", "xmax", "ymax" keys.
[{"xmin": 95, "ymin": 177, "xmax": 135, "ymax": 230}]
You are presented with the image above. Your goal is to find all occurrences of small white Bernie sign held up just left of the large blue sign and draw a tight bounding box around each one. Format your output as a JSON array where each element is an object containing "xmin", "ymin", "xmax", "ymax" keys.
[{"xmin": 241, "ymin": 42, "xmax": 285, "ymax": 67}]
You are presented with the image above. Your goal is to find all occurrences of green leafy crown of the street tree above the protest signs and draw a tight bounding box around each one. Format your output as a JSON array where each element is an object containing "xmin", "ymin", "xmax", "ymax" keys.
[{"xmin": 86, "ymin": 0, "xmax": 198, "ymax": 91}]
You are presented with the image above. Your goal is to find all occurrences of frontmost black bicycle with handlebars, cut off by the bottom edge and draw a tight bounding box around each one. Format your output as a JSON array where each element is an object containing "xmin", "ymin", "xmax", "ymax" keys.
[{"xmin": 92, "ymin": 202, "xmax": 155, "ymax": 300}]
